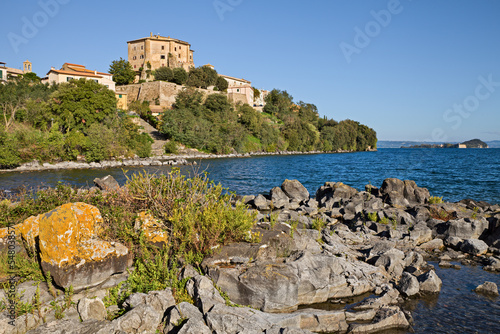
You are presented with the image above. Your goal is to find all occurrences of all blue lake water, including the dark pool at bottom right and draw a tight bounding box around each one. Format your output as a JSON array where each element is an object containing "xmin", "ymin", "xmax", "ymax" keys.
[{"xmin": 0, "ymin": 149, "xmax": 500, "ymax": 333}]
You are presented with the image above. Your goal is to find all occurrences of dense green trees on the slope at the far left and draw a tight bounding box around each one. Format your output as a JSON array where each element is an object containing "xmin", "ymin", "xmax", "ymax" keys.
[{"xmin": 0, "ymin": 76, "xmax": 152, "ymax": 168}]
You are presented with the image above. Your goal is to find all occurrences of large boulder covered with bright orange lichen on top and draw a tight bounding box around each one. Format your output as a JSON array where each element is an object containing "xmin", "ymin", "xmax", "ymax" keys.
[{"xmin": 39, "ymin": 203, "xmax": 128, "ymax": 291}]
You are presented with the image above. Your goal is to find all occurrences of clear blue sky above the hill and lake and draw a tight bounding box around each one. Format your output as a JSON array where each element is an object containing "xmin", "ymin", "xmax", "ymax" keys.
[{"xmin": 0, "ymin": 0, "xmax": 500, "ymax": 141}]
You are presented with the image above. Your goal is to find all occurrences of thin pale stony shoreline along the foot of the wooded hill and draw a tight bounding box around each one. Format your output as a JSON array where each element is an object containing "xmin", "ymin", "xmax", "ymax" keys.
[{"xmin": 0, "ymin": 150, "xmax": 376, "ymax": 173}]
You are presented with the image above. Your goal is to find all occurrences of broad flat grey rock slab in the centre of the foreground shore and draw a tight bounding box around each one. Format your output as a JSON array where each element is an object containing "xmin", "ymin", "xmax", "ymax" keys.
[{"xmin": 204, "ymin": 251, "xmax": 387, "ymax": 312}]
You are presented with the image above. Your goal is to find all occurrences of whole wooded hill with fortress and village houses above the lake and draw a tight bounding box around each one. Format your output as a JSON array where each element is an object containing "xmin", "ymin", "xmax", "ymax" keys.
[{"xmin": 0, "ymin": 33, "xmax": 377, "ymax": 170}]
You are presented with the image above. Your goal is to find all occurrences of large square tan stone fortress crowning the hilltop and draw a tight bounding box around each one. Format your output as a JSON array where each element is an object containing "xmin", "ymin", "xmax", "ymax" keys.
[{"xmin": 127, "ymin": 33, "xmax": 194, "ymax": 79}]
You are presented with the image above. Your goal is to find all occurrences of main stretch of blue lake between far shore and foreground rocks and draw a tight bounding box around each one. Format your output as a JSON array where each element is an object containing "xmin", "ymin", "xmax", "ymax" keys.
[{"xmin": 0, "ymin": 149, "xmax": 500, "ymax": 204}]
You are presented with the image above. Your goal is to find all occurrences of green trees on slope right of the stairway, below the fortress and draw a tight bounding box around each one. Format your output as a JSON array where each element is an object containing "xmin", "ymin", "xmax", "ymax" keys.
[{"xmin": 159, "ymin": 89, "xmax": 377, "ymax": 153}]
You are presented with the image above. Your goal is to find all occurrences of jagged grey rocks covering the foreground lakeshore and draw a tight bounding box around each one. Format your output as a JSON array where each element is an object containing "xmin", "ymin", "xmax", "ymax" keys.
[{"xmin": 0, "ymin": 178, "xmax": 500, "ymax": 334}]
